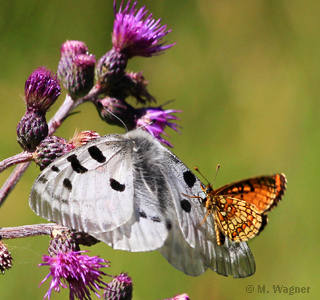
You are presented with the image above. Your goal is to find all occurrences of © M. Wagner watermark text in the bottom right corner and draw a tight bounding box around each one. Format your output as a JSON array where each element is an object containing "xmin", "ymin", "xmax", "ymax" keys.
[{"xmin": 246, "ymin": 284, "xmax": 311, "ymax": 295}]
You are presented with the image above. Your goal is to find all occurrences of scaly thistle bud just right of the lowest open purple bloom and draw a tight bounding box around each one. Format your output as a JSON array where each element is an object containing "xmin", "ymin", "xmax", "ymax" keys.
[{"xmin": 103, "ymin": 273, "xmax": 133, "ymax": 300}]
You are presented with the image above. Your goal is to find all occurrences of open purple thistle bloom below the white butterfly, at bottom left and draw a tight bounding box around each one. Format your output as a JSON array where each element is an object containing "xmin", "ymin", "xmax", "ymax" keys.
[{"xmin": 39, "ymin": 251, "xmax": 109, "ymax": 300}]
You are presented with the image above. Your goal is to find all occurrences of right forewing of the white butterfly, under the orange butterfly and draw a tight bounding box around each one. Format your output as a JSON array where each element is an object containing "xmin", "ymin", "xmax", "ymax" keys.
[{"xmin": 161, "ymin": 148, "xmax": 255, "ymax": 278}]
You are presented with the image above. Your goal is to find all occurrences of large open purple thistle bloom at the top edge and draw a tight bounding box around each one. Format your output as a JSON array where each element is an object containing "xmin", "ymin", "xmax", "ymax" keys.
[{"xmin": 112, "ymin": 0, "xmax": 175, "ymax": 58}]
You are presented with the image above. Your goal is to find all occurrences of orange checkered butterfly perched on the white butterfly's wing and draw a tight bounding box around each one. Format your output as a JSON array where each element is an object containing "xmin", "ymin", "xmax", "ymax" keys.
[{"xmin": 188, "ymin": 166, "xmax": 287, "ymax": 245}]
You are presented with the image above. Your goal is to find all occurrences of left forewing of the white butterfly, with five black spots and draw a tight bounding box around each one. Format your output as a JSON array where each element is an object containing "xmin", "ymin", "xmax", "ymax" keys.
[{"xmin": 29, "ymin": 135, "xmax": 134, "ymax": 235}]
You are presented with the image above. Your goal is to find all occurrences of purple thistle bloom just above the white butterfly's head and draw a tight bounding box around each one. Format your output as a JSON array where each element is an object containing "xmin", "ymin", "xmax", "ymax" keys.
[{"xmin": 136, "ymin": 106, "xmax": 182, "ymax": 147}]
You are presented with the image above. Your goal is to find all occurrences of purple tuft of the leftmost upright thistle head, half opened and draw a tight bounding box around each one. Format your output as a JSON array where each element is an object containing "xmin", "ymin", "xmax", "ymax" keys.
[{"xmin": 24, "ymin": 67, "xmax": 61, "ymax": 113}]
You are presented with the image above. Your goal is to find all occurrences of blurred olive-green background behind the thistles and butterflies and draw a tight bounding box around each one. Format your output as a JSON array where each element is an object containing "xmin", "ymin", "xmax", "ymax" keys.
[{"xmin": 0, "ymin": 0, "xmax": 320, "ymax": 300}]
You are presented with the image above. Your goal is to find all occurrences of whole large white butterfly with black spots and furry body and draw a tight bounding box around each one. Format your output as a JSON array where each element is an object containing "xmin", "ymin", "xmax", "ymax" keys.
[{"xmin": 30, "ymin": 129, "xmax": 255, "ymax": 278}]
